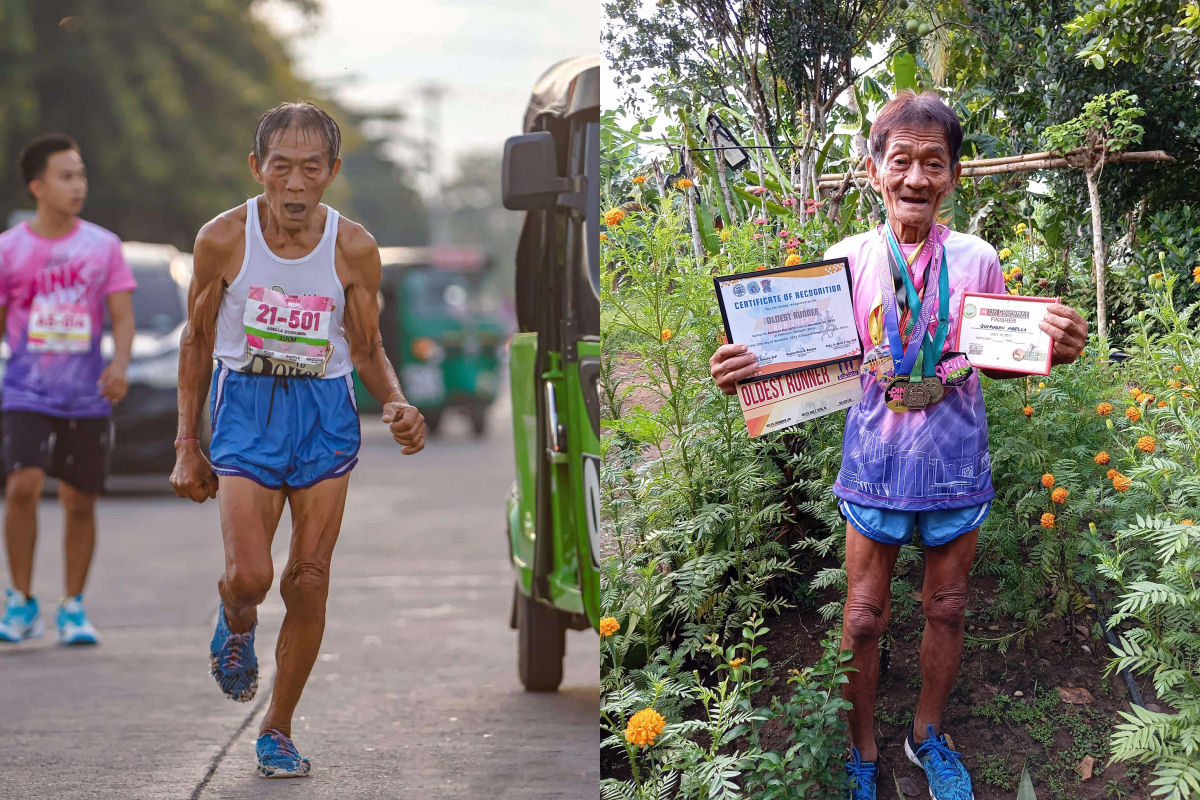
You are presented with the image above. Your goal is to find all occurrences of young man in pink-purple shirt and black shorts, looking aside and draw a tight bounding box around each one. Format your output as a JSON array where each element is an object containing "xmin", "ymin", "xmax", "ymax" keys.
[{"xmin": 0, "ymin": 133, "xmax": 137, "ymax": 644}]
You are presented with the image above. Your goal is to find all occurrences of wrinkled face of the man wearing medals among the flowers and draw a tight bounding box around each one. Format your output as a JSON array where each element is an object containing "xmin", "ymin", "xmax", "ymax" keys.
[{"xmin": 866, "ymin": 126, "xmax": 962, "ymax": 237}]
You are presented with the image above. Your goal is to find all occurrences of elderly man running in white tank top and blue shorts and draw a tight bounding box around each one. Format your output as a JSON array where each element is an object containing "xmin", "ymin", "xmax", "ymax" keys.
[{"xmin": 170, "ymin": 103, "xmax": 425, "ymax": 777}]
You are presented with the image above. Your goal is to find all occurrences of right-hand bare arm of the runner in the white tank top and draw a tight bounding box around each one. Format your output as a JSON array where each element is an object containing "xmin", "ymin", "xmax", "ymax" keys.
[{"xmin": 337, "ymin": 219, "xmax": 425, "ymax": 456}]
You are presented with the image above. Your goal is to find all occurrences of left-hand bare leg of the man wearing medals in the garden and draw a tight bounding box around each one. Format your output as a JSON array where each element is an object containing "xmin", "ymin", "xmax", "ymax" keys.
[{"xmin": 841, "ymin": 523, "xmax": 900, "ymax": 762}]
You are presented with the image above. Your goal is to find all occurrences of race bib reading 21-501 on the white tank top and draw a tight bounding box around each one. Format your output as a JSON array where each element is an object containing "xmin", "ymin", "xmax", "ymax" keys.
[{"xmin": 241, "ymin": 287, "xmax": 334, "ymax": 378}]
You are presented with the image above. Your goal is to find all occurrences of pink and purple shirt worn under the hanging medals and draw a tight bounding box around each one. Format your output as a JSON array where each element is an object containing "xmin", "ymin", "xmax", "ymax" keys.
[{"xmin": 826, "ymin": 225, "xmax": 1004, "ymax": 511}]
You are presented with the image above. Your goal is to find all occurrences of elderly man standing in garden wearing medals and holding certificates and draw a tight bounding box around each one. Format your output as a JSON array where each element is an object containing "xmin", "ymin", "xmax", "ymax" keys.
[{"xmin": 709, "ymin": 91, "xmax": 1087, "ymax": 800}]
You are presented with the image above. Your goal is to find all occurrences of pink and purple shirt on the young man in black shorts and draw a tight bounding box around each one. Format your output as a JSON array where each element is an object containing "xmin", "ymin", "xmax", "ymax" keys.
[{"xmin": 0, "ymin": 219, "xmax": 137, "ymax": 417}]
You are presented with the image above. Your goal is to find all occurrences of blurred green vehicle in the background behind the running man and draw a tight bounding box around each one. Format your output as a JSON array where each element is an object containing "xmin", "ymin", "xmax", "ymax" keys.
[{"xmin": 355, "ymin": 247, "xmax": 505, "ymax": 437}]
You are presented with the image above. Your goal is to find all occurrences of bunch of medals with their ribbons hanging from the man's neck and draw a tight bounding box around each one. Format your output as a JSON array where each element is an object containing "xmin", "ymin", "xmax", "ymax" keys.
[{"xmin": 880, "ymin": 224, "xmax": 955, "ymax": 413}]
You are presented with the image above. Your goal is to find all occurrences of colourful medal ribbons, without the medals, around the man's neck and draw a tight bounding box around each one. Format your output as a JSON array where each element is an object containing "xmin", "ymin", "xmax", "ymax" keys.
[{"xmin": 878, "ymin": 224, "xmax": 950, "ymax": 378}]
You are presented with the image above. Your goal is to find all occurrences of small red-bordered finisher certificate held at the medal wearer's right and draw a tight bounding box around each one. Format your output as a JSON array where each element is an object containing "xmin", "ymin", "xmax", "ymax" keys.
[{"xmin": 955, "ymin": 291, "xmax": 1058, "ymax": 375}]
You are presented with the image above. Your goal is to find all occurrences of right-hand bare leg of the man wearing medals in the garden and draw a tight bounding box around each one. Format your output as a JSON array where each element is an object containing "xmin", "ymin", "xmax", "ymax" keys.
[{"xmin": 912, "ymin": 528, "xmax": 979, "ymax": 744}]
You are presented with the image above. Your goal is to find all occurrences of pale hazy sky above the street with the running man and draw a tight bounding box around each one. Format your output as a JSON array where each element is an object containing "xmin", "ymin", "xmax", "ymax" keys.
[{"xmin": 260, "ymin": 0, "xmax": 600, "ymax": 183}]
